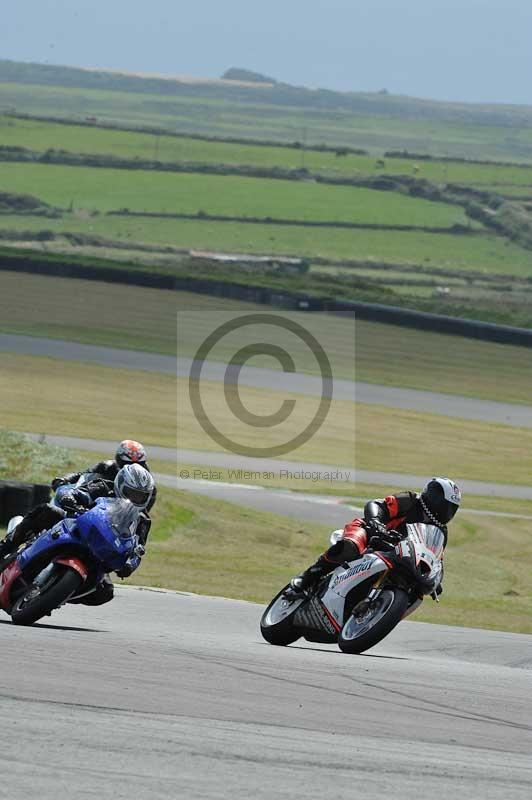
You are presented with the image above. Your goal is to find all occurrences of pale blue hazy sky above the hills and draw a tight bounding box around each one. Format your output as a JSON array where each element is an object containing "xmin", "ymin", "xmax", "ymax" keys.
[{"xmin": 4, "ymin": 0, "xmax": 532, "ymax": 104}]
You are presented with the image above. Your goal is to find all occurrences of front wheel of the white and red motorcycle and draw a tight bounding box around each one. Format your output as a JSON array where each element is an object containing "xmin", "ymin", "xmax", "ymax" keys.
[{"xmin": 338, "ymin": 586, "xmax": 409, "ymax": 653}]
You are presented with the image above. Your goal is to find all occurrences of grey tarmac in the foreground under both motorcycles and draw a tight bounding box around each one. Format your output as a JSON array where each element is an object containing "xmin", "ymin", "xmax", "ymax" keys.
[{"xmin": 0, "ymin": 575, "xmax": 532, "ymax": 800}]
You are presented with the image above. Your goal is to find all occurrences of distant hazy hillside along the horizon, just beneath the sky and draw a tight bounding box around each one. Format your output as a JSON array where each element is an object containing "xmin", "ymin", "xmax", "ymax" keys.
[{"xmin": 0, "ymin": 60, "xmax": 532, "ymax": 161}]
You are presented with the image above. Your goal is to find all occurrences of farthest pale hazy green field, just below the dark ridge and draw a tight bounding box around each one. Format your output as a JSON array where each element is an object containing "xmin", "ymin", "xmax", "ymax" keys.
[{"xmin": 0, "ymin": 82, "xmax": 532, "ymax": 161}]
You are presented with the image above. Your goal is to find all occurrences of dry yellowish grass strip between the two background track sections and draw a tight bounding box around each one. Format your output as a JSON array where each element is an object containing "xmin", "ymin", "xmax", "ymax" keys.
[{"xmin": 4, "ymin": 354, "xmax": 532, "ymax": 484}]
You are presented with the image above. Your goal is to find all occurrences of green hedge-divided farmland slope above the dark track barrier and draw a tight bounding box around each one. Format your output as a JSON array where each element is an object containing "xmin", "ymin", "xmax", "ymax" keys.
[{"xmin": 0, "ymin": 109, "xmax": 532, "ymax": 326}]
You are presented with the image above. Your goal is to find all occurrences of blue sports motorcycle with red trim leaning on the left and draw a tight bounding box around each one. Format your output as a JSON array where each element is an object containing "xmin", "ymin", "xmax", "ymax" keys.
[{"xmin": 0, "ymin": 497, "xmax": 144, "ymax": 625}]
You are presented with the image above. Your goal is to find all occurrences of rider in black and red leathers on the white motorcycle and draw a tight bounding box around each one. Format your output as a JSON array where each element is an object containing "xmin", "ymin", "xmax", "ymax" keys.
[{"xmin": 286, "ymin": 478, "xmax": 462, "ymax": 596}]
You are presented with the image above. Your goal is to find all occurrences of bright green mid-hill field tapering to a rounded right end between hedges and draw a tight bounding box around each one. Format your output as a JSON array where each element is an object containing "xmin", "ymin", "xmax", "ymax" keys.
[{"xmin": 0, "ymin": 163, "xmax": 467, "ymax": 227}]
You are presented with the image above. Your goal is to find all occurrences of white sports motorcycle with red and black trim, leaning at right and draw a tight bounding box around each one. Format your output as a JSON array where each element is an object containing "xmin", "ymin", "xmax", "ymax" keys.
[{"xmin": 260, "ymin": 522, "xmax": 445, "ymax": 653}]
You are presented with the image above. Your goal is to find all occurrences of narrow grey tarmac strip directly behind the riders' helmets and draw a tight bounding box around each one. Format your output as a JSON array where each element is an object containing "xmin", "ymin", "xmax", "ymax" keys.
[{"xmin": 28, "ymin": 433, "xmax": 532, "ymax": 500}]
